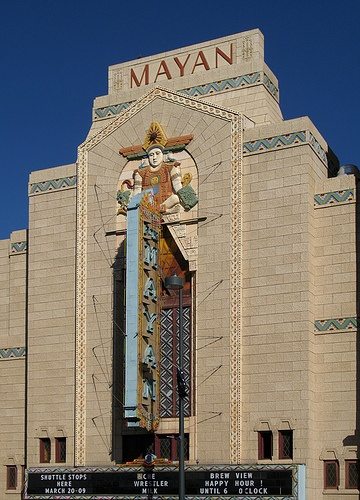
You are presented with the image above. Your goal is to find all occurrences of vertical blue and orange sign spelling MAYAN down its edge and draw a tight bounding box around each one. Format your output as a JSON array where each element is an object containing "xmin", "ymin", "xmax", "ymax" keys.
[{"xmin": 124, "ymin": 192, "xmax": 161, "ymax": 431}]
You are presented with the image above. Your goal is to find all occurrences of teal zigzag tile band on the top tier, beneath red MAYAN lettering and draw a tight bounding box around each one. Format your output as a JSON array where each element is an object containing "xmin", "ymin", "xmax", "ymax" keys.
[{"xmin": 94, "ymin": 71, "xmax": 279, "ymax": 120}]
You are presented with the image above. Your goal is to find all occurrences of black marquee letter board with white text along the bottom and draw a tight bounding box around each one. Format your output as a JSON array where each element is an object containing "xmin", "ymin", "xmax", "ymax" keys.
[{"xmin": 25, "ymin": 465, "xmax": 298, "ymax": 500}]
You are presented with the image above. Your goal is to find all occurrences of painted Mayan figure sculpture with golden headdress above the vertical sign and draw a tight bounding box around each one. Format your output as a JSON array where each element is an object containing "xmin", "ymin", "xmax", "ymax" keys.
[{"xmin": 117, "ymin": 122, "xmax": 198, "ymax": 214}]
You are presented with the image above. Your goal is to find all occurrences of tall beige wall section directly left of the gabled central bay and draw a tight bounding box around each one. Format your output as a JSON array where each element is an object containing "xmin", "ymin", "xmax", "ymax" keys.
[{"xmin": 27, "ymin": 165, "xmax": 76, "ymax": 466}]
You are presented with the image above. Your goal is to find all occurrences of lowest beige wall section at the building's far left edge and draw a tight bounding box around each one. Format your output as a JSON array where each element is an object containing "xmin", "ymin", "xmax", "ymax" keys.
[{"xmin": 0, "ymin": 231, "xmax": 27, "ymax": 498}]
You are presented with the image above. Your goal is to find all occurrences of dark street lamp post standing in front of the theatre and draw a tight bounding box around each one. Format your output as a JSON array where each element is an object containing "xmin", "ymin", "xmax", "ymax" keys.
[{"xmin": 165, "ymin": 274, "xmax": 187, "ymax": 500}]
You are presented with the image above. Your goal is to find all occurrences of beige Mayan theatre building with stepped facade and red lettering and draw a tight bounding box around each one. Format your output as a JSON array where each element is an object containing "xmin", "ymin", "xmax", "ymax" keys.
[{"xmin": 0, "ymin": 30, "xmax": 359, "ymax": 500}]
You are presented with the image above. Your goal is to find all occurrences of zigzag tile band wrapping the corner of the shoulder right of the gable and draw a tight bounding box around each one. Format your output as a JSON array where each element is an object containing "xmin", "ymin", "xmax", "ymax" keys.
[{"xmin": 243, "ymin": 130, "xmax": 327, "ymax": 165}]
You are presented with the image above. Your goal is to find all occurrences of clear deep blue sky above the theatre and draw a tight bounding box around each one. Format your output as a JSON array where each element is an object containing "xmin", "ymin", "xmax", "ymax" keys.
[{"xmin": 0, "ymin": 0, "xmax": 360, "ymax": 239}]
